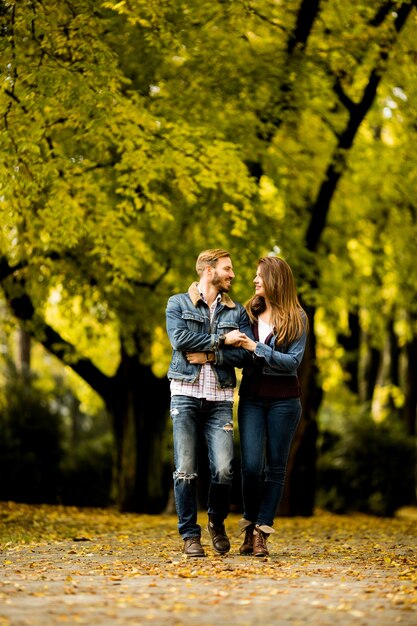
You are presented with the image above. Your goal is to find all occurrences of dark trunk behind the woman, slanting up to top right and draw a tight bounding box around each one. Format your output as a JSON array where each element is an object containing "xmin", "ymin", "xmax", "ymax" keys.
[{"xmin": 279, "ymin": 2, "xmax": 412, "ymax": 515}]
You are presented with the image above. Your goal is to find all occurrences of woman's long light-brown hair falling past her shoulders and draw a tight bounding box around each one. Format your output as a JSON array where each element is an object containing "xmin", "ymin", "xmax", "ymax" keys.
[{"xmin": 246, "ymin": 256, "xmax": 307, "ymax": 345}]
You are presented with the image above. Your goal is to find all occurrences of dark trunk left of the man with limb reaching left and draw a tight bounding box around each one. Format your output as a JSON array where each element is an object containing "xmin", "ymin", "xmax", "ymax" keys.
[{"xmin": 6, "ymin": 280, "xmax": 170, "ymax": 513}]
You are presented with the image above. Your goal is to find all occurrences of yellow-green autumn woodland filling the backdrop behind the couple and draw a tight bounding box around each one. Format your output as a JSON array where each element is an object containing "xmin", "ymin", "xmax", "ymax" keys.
[{"xmin": 0, "ymin": 0, "xmax": 417, "ymax": 516}]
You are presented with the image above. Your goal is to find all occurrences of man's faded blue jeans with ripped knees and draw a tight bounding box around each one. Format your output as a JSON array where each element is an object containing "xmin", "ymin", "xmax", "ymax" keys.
[{"xmin": 171, "ymin": 395, "xmax": 233, "ymax": 539}]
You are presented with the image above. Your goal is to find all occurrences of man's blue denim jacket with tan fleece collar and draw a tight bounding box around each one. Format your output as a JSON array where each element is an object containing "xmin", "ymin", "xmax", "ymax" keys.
[{"xmin": 166, "ymin": 282, "xmax": 252, "ymax": 388}]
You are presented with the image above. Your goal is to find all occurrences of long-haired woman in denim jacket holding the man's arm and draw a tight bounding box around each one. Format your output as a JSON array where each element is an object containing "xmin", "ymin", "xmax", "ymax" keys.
[{"xmin": 228, "ymin": 257, "xmax": 307, "ymax": 557}]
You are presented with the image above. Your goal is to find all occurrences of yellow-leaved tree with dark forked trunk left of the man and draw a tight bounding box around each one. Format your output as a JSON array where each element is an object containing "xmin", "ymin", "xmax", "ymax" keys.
[{"xmin": 0, "ymin": 1, "xmax": 255, "ymax": 511}]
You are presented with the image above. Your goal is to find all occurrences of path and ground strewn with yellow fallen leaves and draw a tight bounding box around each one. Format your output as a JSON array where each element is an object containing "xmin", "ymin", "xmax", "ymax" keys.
[{"xmin": 0, "ymin": 503, "xmax": 417, "ymax": 626}]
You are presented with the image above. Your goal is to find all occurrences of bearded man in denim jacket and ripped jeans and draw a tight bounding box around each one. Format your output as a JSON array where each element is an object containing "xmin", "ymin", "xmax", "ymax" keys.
[{"xmin": 166, "ymin": 249, "xmax": 251, "ymax": 557}]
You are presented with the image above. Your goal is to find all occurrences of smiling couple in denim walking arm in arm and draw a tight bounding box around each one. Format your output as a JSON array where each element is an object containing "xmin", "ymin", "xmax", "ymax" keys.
[{"xmin": 166, "ymin": 249, "xmax": 307, "ymax": 557}]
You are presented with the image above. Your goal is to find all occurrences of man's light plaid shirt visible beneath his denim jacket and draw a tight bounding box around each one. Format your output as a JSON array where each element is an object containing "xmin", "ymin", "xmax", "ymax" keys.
[{"xmin": 171, "ymin": 291, "xmax": 234, "ymax": 402}]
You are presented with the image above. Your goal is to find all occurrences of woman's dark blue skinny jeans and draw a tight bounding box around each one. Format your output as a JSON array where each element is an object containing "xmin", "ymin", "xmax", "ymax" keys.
[{"xmin": 238, "ymin": 398, "xmax": 301, "ymax": 526}]
